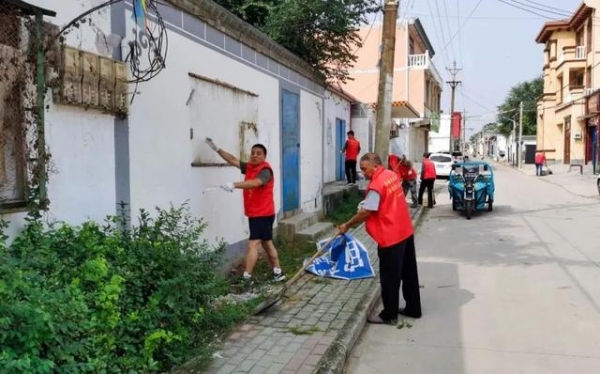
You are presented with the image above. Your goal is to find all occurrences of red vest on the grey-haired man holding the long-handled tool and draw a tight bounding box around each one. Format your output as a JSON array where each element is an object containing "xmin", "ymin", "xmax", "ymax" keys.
[{"xmin": 365, "ymin": 168, "xmax": 414, "ymax": 248}]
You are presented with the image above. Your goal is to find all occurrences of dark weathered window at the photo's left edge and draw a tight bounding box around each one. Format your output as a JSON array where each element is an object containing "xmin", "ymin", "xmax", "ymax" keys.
[{"xmin": 0, "ymin": 9, "xmax": 27, "ymax": 207}]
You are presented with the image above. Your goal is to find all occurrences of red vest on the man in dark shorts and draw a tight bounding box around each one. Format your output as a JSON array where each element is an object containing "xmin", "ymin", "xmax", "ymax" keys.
[{"xmin": 244, "ymin": 162, "xmax": 275, "ymax": 217}]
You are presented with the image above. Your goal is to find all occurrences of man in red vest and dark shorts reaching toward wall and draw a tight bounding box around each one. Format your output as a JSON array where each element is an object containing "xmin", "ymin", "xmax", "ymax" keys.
[{"xmin": 206, "ymin": 138, "xmax": 285, "ymax": 281}]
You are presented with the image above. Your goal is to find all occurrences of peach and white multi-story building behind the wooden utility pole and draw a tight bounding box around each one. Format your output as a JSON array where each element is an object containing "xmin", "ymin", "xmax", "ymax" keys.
[{"xmin": 344, "ymin": 19, "xmax": 443, "ymax": 159}]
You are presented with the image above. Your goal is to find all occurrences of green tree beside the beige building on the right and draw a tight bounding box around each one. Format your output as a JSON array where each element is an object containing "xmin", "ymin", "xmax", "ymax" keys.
[{"xmin": 497, "ymin": 76, "xmax": 544, "ymax": 136}]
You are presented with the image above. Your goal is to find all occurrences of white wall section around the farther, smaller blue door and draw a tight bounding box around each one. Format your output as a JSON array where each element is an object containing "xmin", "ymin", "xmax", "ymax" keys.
[{"xmin": 323, "ymin": 91, "xmax": 352, "ymax": 183}]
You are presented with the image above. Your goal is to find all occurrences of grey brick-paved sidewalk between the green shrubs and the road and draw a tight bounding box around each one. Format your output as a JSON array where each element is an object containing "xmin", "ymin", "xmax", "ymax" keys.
[{"xmin": 195, "ymin": 207, "xmax": 422, "ymax": 374}]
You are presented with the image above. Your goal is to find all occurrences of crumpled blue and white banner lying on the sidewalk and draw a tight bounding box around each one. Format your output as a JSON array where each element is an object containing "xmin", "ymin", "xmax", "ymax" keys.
[{"xmin": 306, "ymin": 234, "xmax": 375, "ymax": 280}]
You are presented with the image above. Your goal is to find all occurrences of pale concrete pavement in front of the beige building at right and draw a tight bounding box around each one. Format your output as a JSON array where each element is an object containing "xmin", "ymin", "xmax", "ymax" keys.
[{"xmin": 496, "ymin": 163, "xmax": 598, "ymax": 199}]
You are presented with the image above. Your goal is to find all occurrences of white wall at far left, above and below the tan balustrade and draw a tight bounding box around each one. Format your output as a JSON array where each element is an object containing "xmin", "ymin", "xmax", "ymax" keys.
[{"xmin": 4, "ymin": 0, "xmax": 116, "ymax": 240}]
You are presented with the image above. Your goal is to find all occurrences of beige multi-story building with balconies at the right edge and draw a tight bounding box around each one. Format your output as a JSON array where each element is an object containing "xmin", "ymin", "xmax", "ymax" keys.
[{"xmin": 536, "ymin": 0, "xmax": 600, "ymax": 170}]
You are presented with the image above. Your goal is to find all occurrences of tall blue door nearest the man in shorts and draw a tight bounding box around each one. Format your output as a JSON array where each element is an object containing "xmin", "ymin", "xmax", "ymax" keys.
[{"xmin": 281, "ymin": 90, "xmax": 300, "ymax": 212}]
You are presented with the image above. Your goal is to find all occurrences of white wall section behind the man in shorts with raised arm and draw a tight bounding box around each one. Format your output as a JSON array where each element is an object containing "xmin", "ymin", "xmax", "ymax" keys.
[{"xmin": 126, "ymin": 8, "xmax": 284, "ymax": 247}]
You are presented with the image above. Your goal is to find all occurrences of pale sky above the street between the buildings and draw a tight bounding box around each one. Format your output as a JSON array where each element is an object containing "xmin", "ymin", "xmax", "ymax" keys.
[{"xmin": 384, "ymin": 0, "xmax": 583, "ymax": 139}]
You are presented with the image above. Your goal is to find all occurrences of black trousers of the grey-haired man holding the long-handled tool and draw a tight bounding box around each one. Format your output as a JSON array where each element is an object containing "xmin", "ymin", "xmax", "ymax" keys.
[{"xmin": 377, "ymin": 235, "xmax": 421, "ymax": 321}]
